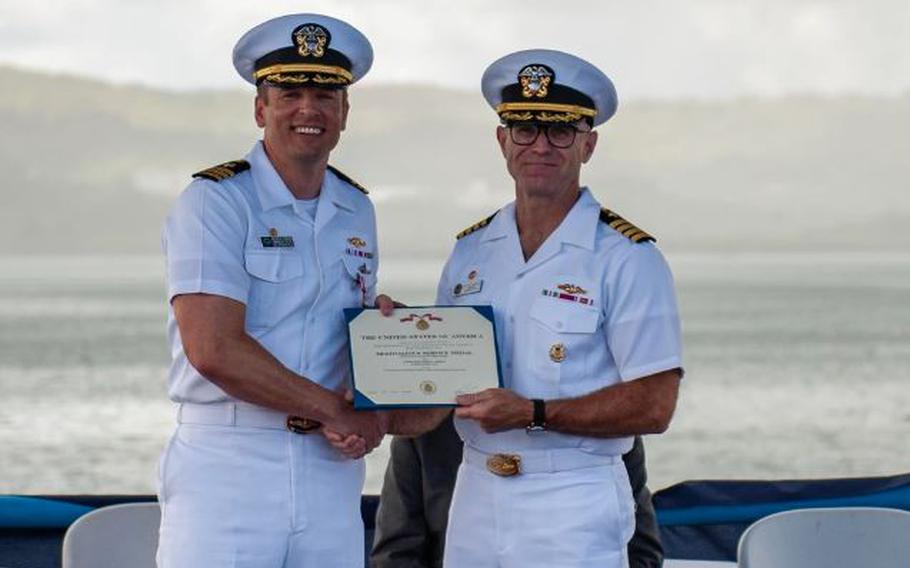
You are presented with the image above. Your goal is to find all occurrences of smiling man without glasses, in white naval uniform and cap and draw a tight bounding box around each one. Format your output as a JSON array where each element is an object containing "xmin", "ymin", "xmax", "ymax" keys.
[{"xmin": 158, "ymin": 14, "xmax": 391, "ymax": 568}]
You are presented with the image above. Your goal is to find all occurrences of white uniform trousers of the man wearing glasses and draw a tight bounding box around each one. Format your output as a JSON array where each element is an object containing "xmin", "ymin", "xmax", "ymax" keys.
[{"xmin": 443, "ymin": 446, "xmax": 635, "ymax": 568}]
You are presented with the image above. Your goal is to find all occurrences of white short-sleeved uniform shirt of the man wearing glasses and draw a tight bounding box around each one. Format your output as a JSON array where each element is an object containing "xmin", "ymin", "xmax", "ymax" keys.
[{"xmin": 437, "ymin": 188, "xmax": 682, "ymax": 455}]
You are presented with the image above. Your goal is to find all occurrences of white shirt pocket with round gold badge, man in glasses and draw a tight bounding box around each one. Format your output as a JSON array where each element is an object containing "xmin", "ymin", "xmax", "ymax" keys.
[{"xmin": 530, "ymin": 298, "xmax": 606, "ymax": 385}]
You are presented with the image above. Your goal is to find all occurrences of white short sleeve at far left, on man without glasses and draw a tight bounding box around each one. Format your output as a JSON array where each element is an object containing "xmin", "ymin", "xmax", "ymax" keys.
[{"xmin": 162, "ymin": 181, "xmax": 250, "ymax": 304}]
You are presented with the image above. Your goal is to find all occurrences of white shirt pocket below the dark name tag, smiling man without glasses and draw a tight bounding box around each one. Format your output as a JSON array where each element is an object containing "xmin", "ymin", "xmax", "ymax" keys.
[{"xmin": 244, "ymin": 251, "xmax": 303, "ymax": 329}]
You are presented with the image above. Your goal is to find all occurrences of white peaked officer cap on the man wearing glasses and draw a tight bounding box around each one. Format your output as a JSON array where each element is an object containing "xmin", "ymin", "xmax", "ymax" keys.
[{"xmin": 480, "ymin": 49, "xmax": 618, "ymax": 126}]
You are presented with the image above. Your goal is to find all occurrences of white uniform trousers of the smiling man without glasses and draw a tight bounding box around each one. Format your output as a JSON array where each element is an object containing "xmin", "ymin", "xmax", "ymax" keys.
[{"xmin": 158, "ymin": 404, "xmax": 364, "ymax": 568}]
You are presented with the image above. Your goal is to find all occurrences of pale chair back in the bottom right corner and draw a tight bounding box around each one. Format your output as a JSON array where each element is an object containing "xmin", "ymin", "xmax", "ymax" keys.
[{"xmin": 737, "ymin": 507, "xmax": 910, "ymax": 568}]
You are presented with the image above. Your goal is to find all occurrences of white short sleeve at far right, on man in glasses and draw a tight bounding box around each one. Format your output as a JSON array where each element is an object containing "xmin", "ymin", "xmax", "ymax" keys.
[{"xmin": 604, "ymin": 243, "xmax": 682, "ymax": 381}]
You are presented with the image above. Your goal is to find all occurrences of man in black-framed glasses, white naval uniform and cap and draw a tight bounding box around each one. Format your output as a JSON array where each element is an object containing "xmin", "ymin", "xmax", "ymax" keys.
[{"xmin": 437, "ymin": 50, "xmax": 682, "ymax": 568}]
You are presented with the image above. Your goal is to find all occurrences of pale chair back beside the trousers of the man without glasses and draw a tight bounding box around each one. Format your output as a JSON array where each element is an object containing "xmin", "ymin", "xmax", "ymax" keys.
[{"xmin": 63, "ymin": 503, "xmax": 161, "ymax": 568}]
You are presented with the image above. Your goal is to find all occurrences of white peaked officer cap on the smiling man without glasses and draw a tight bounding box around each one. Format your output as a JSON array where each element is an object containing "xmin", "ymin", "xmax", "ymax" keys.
[{"xmin": 234, "ymin": 14, "xmax": 373, "ymax": 88}]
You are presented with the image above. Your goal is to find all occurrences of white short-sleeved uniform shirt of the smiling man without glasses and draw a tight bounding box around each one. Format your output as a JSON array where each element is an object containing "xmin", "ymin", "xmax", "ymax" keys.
[{"xmin": 163, "ymin": 142, "xmax": 378, "ymax": 403}]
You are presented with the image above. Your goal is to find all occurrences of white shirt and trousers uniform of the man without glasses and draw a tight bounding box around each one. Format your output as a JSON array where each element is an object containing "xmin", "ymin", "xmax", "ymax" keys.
[{"xmin": 158, "ymin": 142, "xmax": 378, "ymax": 568}]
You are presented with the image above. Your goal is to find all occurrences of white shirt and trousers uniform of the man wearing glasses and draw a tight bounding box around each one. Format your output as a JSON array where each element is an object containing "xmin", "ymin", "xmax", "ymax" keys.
[{"xmin": 437, "ymin": 189, "xmax": 682, "ymax": 568}]
